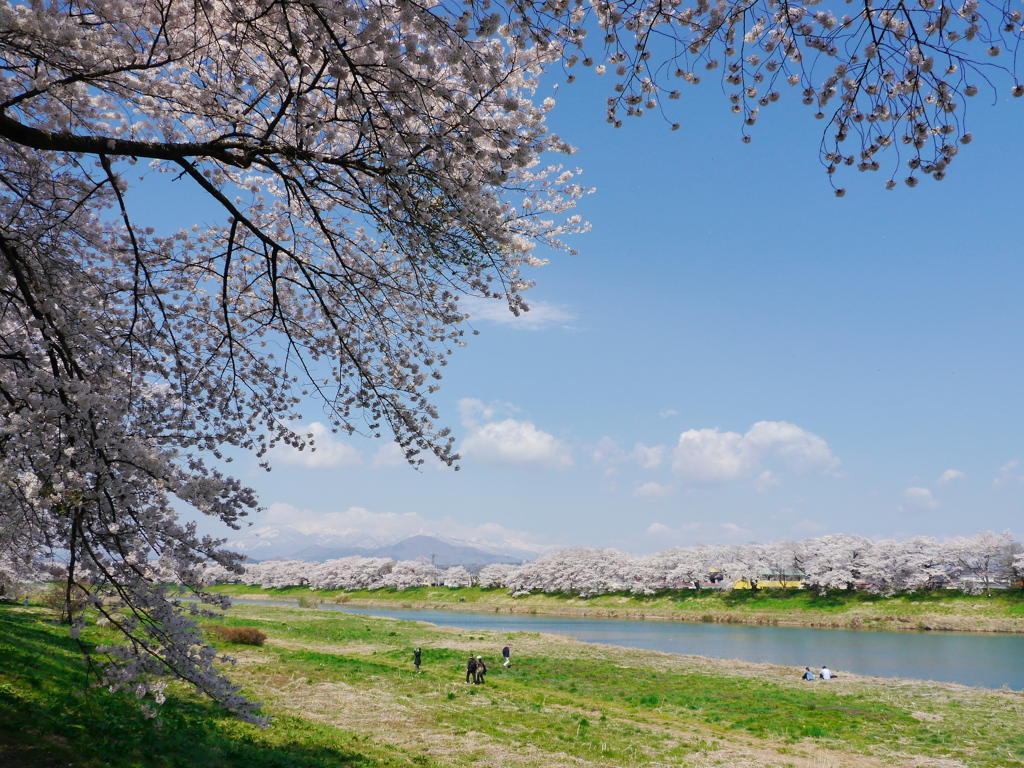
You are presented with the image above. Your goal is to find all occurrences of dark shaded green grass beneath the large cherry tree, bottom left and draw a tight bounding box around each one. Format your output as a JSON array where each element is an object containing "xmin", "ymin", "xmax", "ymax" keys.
[{"xmin": 0, "ymin": 607, "xmax": 418, "ymax": 768}]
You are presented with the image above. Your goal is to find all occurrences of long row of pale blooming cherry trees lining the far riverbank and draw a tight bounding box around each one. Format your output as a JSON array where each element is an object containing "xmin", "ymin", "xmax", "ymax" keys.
[{"xmin": 206, "ymin": 530, "xmax": 1024, "ymax": 597}]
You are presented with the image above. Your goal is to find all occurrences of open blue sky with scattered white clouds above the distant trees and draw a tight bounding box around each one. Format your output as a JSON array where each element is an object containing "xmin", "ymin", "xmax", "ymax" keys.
[{"xmin": 180, "ymin": 61, "xmax": 1024, "ymax": 552}]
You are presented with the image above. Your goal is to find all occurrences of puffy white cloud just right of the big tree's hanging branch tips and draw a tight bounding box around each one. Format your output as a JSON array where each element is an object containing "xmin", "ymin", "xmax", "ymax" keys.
[{"xmin": 459, "ymin": 399, "xmax": 572, "ymax": 470}]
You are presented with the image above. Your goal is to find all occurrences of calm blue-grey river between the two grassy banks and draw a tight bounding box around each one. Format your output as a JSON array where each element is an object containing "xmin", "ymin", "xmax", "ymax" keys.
[{"xmin": 226, "ymin": 600, "xmax": 1024, "ymax": 690}]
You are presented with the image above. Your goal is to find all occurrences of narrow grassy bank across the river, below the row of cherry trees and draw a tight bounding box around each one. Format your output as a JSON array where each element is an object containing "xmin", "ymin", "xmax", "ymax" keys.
[{"xmin": 205, "ymin": 585, "xmax": 1024, "ymax": 634}]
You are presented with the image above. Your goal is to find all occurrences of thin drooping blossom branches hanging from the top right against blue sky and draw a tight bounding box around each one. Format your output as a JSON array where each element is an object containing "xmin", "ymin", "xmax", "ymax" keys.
[{"xmin": 531, "ymin": 0, "xmax": 1024, "ymax": 188}]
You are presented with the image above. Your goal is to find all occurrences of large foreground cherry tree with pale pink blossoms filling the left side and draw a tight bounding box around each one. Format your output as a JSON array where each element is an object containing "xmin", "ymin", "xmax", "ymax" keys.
[{"xmin": 0, "ymin": 0, "xmax": 584, "ymax": 722}]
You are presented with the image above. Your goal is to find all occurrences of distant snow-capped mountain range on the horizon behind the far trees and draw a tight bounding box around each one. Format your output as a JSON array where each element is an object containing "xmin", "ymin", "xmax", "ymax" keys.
[{"xmin": 226, "ymin": 525, "xmax": 553, "ymax": 565}]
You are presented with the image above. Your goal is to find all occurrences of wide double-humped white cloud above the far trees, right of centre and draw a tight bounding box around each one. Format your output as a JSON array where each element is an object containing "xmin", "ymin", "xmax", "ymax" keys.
[{"xmin": 672, "ymin": 421, "xmax": 839, "ymax": 485}]
